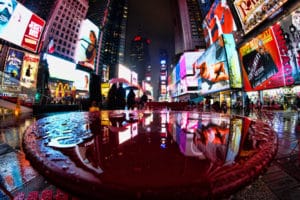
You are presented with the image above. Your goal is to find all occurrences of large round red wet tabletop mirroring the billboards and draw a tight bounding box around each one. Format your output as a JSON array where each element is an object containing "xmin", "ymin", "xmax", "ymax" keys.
[{"xmin": 24, "ymin": 111, "xmax": 277, "ymax": 197}]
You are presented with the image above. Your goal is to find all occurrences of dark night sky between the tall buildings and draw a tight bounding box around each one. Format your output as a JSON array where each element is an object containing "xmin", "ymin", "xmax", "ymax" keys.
[{"xmin": 126, "ymin": 0, "xmax": 174, "ymax": 97}]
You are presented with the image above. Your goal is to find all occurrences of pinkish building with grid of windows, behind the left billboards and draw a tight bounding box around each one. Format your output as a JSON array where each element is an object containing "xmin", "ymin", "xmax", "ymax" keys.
[{"xmin": 35, "ymin": 0, "xmax": 88, "ymax": 61}]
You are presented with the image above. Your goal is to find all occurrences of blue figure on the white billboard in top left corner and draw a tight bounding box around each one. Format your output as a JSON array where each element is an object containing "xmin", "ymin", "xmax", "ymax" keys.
[{"xmin": 0, "ymin": 0, "xmax": 17, "ymax": 34}]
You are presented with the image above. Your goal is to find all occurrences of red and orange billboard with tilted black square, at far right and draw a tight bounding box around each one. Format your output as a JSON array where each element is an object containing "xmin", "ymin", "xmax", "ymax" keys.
[{"xmin": 239, "ymin": 19, "xmax": 300, "ymax": 91}]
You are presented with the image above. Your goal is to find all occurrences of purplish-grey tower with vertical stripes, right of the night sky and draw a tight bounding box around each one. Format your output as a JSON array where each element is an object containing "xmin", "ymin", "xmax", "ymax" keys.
[{"xmin": 173, "ymin": 0, "xmax": 205, "ymax": 54}]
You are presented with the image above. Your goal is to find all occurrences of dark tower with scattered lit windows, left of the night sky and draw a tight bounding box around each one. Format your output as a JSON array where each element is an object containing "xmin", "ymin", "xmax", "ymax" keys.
[{"xmin": 99, "ymin": 0, "xmax": 128, "ymax": 81}]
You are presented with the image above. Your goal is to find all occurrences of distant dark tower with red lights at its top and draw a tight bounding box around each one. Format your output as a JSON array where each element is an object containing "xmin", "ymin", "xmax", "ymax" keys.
[{"xmin": 129, "ymin": 28, "xmax": 151, "ymax": 82}]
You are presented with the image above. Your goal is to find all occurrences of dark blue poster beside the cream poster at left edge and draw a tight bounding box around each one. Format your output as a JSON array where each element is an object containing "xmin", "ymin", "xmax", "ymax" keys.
[{"xmin": 3, "ymin": 48, "xmax": 25, "ymax": 86}]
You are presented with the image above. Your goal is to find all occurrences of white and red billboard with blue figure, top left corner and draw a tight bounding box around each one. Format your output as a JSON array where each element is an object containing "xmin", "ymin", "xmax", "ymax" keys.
[{"xmin": 0, "ymin": 0, "xmax": 45, "ymax": 52}]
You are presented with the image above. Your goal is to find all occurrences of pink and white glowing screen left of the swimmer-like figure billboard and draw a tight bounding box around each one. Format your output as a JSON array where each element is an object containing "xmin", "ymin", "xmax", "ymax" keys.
[{"xmin": 179, "ymin": 51, "xmax": 203, "ymax": 78}]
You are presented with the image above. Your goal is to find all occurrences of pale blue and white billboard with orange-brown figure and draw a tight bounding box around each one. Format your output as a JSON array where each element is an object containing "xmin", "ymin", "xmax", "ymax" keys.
[{"xmin": 194, "ymin": 37, "xmax": 230, "ymax": 94}]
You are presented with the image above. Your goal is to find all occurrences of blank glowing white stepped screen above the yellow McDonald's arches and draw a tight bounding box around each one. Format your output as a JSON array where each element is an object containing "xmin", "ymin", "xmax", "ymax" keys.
[{"xmin": 44, "ymin": 54, "xmax": 90, "ymax": 91}]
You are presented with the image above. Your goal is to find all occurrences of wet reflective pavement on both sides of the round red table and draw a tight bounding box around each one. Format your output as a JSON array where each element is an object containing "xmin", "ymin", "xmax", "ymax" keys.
[{"xmin": 0, "ymin": 108, "xmax": 300, "ymax": 199}]
